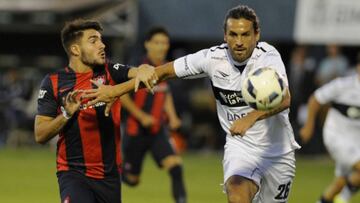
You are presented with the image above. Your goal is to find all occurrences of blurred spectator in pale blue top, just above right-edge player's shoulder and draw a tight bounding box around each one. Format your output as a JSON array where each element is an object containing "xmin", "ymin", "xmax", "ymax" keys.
[{"xmin": 315, "ymin": 44, "xmax": 349, "ymax": 86}]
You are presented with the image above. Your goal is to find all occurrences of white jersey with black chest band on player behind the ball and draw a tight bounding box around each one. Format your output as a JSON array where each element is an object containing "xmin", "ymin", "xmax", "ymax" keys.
[{"xmin": 174, "ymin": 42, "xmax": 300, "ymax": 157}]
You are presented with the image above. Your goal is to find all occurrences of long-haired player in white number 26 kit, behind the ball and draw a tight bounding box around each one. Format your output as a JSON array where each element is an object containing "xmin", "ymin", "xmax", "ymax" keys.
[{"xmin": 83, "ymin": 5, "xmax": 300, "ymax": 203}]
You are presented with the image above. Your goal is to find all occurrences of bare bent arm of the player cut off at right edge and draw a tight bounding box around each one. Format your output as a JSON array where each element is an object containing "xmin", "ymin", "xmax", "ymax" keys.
[{"xmin": 300, "ymin": 94, "xmax": 322, "ymax": 143}]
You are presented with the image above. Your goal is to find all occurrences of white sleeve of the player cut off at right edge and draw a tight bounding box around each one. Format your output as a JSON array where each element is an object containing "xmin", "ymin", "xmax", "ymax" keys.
[{"xmin": 314, "ymin": 78, "xmax": 344, "ymax": 104}]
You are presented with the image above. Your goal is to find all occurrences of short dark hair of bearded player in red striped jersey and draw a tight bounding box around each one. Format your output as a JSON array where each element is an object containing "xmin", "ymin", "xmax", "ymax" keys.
[{"xmin": 61, "ymin": 19, "xmax": 103, "ymax": 55}]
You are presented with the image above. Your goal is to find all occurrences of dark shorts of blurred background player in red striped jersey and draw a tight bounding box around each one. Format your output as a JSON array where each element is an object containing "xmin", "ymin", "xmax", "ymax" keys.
[{"xmin": 122, "ymin": 128, "xmax": 176, "ymax": 175}]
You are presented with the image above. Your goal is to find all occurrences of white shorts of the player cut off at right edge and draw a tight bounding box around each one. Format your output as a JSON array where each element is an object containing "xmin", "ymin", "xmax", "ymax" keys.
[{"xmin": 323, "ymin": 128, "xmax": 360, "ymax": 176}]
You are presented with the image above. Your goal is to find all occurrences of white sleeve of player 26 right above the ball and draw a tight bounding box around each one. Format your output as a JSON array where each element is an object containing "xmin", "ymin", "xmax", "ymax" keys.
[{"xmin": 262, "ymin": 49, "xmax": 289, "ymax": 87}]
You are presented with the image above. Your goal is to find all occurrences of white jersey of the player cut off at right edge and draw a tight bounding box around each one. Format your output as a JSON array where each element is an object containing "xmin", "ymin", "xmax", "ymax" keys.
[{"xmin": 315, "ymin": 74, "xmax": 360, "ymax": 139}]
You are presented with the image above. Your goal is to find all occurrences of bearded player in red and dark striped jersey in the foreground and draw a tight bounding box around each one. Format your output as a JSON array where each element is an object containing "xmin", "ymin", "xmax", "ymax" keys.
[{"xmin": 35, "ymin": 19, "xmax": 156, "ymax": 203}]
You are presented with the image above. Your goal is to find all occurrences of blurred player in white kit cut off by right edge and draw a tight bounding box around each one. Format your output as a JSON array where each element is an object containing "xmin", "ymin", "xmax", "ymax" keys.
[{"xmin": 300, "ymin": 54, "xmax": 360, "ymax": 203}]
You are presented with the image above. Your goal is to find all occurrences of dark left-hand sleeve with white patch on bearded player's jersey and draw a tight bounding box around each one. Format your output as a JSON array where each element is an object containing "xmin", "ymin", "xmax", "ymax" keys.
[{"xmin": 37, "ymin": 75, "xmax": 58, "ymax": 117}]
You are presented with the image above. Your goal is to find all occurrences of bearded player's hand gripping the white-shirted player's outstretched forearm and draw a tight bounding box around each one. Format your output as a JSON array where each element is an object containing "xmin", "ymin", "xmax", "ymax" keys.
[{"xmin": 135, "ymin": 64, "xmax": 159, "ymax": 93}]
